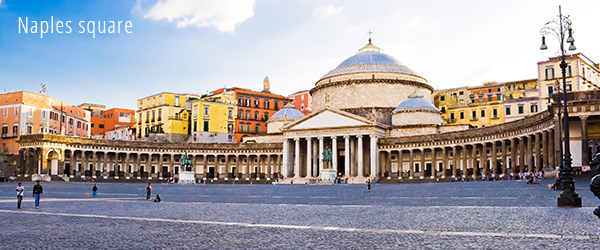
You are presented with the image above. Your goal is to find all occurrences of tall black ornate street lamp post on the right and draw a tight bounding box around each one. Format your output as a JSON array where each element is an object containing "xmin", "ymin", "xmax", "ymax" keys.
[{"xmin": 540, "ymin": 6, "xmax": 581, "ymax": 207}]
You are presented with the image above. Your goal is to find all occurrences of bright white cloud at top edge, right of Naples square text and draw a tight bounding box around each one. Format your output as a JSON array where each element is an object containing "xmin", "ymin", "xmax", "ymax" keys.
[{"xmin": 143, "ymin": 0, "xmax": 255, "ymax": 33}]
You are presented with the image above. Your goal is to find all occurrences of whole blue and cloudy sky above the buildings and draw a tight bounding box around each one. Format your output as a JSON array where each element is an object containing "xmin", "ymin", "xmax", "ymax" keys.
[{"xmin": 0, "ymin": 0, "xmax": 600, "ymax": 109}]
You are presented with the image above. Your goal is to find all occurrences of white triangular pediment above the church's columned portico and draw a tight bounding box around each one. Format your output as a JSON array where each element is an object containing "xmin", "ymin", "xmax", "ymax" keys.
[{"xmin": 284, "ymin": 108, "xmax": 373, "ymax": 131}]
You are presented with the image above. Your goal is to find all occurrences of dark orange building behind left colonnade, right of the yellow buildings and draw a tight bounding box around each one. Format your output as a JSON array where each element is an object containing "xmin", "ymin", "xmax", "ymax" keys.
[{"xmin": 210, "ymin": 77, "xmax": 291, "ymax": 142}]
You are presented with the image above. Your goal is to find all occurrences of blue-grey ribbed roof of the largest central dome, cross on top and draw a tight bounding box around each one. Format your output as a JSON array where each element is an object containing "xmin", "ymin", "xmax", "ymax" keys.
[{"xmin": 321, "ymin": 39, "xmax": 421, "ymax": 80}]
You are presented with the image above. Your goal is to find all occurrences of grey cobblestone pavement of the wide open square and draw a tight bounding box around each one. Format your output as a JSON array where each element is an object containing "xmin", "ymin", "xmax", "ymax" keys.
[{"xmin": 0, "ymin": 179, "xmax": 600, "ymax": 249}]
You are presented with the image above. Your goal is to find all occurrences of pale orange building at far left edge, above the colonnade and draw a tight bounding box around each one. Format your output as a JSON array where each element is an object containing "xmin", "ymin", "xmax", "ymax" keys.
[{"xmin": 0, "ymin": 91, "xmax": 90, "ymax": 154}]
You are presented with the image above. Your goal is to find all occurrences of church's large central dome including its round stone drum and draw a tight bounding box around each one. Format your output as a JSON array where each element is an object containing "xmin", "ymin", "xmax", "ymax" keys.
[{"xmin": 310, "ymin": 39, "xmax": 433, "ymax": 125}]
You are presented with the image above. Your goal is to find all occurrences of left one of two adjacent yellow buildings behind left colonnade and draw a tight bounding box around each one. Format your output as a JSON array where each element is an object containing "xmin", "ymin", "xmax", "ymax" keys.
[{"xmin": 136, "ymin": 92, "xmax": 200, "ymax": 141}]
